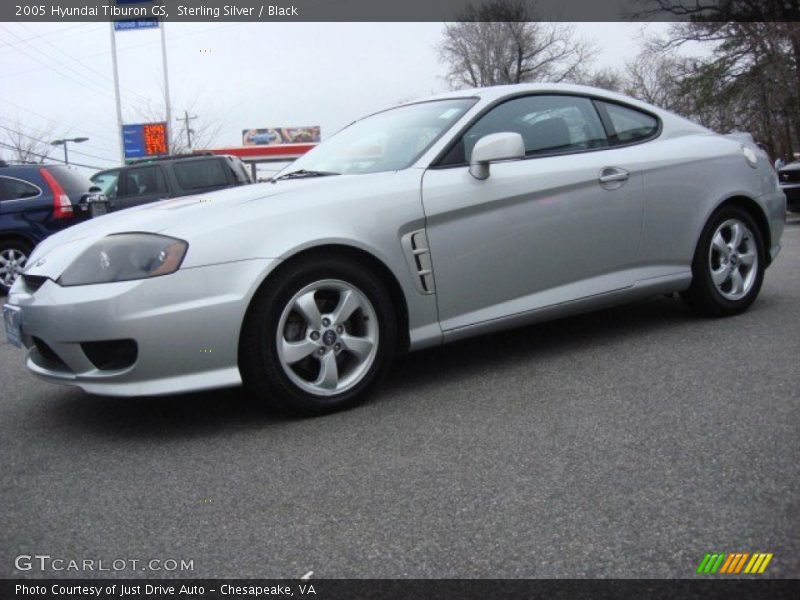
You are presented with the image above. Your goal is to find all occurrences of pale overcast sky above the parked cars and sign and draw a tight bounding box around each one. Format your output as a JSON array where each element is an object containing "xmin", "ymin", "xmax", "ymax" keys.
[{"xmin": 0, "ymin": 23, "xmax": 666, "ymax": 175}]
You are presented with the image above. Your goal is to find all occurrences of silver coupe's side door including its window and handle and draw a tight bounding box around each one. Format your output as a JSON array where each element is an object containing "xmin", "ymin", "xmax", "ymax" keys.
[{"xmin": 422, "ymin": 95, "xmax": 643, "ymax": 331}]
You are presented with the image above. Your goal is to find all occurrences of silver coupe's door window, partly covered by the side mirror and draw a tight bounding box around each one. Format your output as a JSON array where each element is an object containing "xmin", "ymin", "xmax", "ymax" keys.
[{"xmin": 441, "ymin": 95, "xmax": 608, "ymax": 165}]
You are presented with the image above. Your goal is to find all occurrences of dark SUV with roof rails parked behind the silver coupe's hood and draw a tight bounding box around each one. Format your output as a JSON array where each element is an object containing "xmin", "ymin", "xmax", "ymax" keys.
[{"xmin": 92, "ymin": 153, "xmax": 252, "ymax": 210}]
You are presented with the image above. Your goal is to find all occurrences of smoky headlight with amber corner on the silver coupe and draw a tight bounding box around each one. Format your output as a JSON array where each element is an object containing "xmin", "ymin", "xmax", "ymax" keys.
[{"xmin": 58, "ymin": 233, "xmax": 189, "ymax": 286}]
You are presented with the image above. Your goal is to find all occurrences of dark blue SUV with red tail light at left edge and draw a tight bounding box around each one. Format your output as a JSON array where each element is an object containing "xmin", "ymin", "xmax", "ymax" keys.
[{"xmin": 0, "ymin": 161, "xmax": 107, "ymax": 295}]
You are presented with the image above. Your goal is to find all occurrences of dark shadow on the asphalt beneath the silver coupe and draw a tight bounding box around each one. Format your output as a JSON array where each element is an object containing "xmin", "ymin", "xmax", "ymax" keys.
[{"xmin": 39, "ymin": 297, "xmax": 736, "ymax": 439}]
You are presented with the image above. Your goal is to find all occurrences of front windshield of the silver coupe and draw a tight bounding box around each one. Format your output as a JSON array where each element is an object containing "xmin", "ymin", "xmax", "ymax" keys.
[{"xmin": 284, "ymin": 98, "xmax": 476, "ymax": 174}]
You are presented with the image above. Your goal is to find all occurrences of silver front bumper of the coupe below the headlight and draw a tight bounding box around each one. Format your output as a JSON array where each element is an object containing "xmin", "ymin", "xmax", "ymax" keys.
[{"xmin": 8, "ymin": 259, "xmax": 278, "ymax": 396}]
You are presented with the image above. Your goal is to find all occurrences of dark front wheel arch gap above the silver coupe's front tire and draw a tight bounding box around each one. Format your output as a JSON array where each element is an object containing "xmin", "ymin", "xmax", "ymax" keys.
[{"xmin": 239, "ymin": 243, "xmax": 410, "ymax": 352}]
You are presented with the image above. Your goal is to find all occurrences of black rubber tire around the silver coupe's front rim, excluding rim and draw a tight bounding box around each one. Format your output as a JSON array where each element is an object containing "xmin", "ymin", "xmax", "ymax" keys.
[{"xmin": 239, "ymin": 256, "xmax": 397, "ymax": 416}]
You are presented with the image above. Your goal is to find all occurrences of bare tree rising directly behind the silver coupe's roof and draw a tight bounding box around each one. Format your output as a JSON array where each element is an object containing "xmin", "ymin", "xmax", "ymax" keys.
[{"xmin": 438, "ymin": 0, "xmax": 592, "ymax": 89}]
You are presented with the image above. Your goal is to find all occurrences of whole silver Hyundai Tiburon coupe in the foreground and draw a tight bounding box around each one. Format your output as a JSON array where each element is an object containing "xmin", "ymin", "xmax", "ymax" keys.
[{"xmin": 4, "ymin": 85, "xmax": 786, "ymax": 413}]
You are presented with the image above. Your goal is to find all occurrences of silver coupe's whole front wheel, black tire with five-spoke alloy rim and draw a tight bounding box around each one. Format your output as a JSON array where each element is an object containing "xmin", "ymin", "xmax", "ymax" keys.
[{"xmin": 239, "ymin": 257, "xmax": 397, "ymax": 415}]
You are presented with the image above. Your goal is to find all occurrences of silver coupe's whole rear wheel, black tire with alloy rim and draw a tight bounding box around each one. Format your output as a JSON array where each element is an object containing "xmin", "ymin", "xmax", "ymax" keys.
[{"xmin": 681, "ymin": 206, "xmax": 766, "ymax": 317}]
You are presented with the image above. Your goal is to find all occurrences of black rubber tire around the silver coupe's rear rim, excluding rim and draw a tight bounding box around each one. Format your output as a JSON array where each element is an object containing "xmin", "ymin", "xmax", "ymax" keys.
[{"xmin": 681, "ymin": 206, "xmax": 766, "ymax": 317}]
